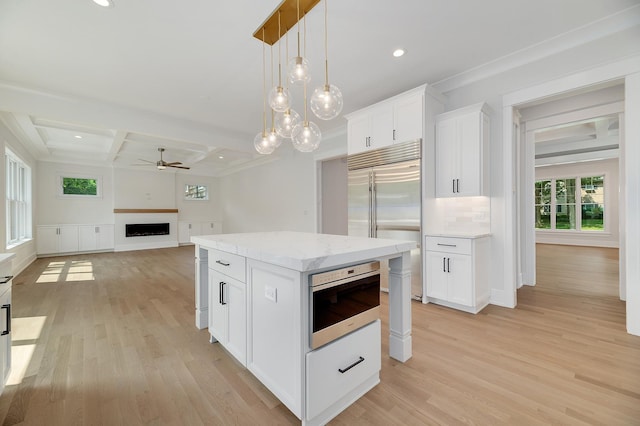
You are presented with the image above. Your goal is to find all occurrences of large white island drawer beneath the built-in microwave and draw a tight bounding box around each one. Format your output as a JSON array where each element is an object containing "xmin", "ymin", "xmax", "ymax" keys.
[{"xmin": 306, "ymin": 320, "xmax": 381, "ymax": 419}]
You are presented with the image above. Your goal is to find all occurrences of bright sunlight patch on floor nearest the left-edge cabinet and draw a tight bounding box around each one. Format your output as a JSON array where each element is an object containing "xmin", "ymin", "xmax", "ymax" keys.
[{"xmin": 7, "ymin": 316, "xmax": 47, "ymax": 385}]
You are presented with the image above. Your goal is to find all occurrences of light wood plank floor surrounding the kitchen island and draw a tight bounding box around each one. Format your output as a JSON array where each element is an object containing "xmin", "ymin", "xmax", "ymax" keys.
[{"xmin": 0, "ymin": 247, "xmax": 640, "ymax": 425}]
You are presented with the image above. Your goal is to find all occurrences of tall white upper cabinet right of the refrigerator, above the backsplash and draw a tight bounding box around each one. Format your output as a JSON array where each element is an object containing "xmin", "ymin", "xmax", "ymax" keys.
[{"xmin": 436, "ymin": 103, "xmax": 489, "ymax": 197}]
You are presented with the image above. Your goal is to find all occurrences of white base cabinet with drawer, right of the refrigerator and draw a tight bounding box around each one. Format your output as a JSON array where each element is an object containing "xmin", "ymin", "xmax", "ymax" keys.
[{"xmin": 425, "ymin": 236, "xmax": 490, "ymax": 314}]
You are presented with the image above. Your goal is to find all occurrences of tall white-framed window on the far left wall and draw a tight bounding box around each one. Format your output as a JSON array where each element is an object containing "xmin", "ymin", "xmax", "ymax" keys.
[{"xmin": 5, "ymin": 149, "xmax": 31, "ymax": 248}]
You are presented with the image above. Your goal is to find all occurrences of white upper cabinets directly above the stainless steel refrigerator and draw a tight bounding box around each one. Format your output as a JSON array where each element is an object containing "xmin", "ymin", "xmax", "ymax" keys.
[{"xmin": 347, "ymin": 86, "xmax": 425, "ymax": 155}]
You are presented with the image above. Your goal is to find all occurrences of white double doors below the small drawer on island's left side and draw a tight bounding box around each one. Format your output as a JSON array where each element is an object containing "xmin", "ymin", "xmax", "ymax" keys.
[{"xmin": 209, "ymin": 269, "xmax": 247, "ymax": 366}]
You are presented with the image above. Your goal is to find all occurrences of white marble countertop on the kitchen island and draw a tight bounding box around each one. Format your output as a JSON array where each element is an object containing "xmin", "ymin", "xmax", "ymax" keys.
[{"xmin": 191, "ymin": 231, "xmax": 416, "ymax": 272}]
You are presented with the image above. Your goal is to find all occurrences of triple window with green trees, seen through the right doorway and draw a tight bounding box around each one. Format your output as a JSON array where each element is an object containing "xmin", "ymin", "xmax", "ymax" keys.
[{"xmin": 534, "ymin": 176, "xmax": 605, "ymax": 231}]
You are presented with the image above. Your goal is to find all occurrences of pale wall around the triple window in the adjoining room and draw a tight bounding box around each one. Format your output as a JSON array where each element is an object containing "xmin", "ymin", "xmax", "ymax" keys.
[{"xmin": 536, "ymin": 158, "xmax": 620, "ymax": 247}]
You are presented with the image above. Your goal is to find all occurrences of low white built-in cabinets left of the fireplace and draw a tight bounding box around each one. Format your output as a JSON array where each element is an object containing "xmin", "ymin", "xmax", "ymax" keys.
[{"xmin": 36, "ymin": 224, "xmax": 114, "ymax": 255}]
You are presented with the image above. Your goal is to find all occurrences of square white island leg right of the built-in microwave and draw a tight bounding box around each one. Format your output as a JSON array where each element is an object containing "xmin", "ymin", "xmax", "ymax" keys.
[{"xmin": 389, "ymin": 251, "xmax": 411, "ymax": 362}]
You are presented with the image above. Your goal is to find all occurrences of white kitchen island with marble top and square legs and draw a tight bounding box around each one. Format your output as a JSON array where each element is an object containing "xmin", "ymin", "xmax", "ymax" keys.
[{"xmin": 191, "ymin": 232, "xmax": 415, "ymax": 425}]
